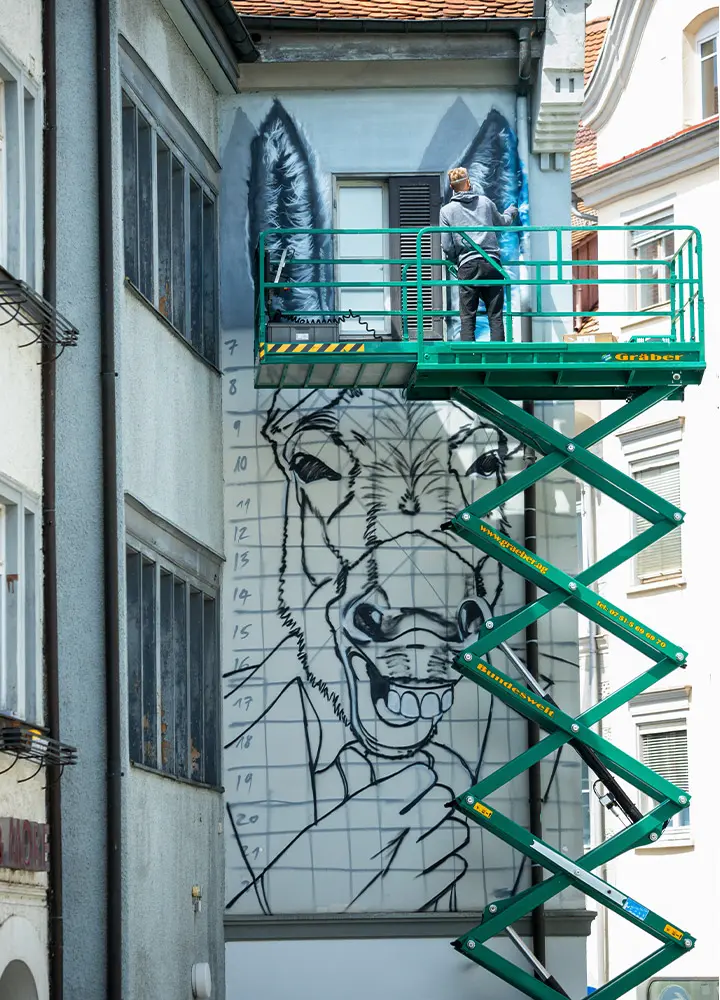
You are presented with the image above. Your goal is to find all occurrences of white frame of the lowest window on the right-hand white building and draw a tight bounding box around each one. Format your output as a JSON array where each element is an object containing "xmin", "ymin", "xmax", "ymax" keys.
[{"xmin": 629, "ymin": 688, "xmax": 693, "ymax": 851}]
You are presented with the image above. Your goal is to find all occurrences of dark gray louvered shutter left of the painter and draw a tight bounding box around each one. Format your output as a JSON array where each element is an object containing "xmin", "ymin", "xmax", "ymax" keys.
[{"xmin": 389, "ymin": 174, "xmax": 442, "ymax": 340}]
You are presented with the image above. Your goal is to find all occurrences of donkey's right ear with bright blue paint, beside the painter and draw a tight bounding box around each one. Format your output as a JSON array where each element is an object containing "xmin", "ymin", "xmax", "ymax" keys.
[{"xmin": 460, "ymin": 108, "xmax": 519, "ymax": 212}]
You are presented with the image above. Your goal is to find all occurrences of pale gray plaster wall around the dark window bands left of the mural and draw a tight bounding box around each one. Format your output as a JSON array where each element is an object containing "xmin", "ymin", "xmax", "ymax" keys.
[{"xmin": 114, "ymin": 0, "xmax": 224, "ymax": 1000}]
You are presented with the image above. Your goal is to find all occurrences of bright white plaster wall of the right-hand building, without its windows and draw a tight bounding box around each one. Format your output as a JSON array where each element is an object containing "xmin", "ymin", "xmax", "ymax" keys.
[{"xmin": 577, "ymin": 0, "xmax": 720, "ymax": 997}]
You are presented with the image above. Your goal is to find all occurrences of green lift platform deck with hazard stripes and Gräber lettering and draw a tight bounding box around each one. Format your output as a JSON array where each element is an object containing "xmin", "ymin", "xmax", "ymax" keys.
[{"xmin": 255, "ymin": 341, "xmax": 705, "ymax": 400}]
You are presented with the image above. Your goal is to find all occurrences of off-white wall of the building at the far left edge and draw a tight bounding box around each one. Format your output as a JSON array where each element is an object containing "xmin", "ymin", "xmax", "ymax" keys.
[{"xmin": 0, "ymin": 7, "xmax": 48, "ymax": 1000}]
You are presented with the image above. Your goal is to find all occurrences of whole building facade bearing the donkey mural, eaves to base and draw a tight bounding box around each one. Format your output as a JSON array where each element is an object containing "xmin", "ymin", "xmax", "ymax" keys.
[{"xmin": 220, "ymin": 3, "xmax": 588, "ymax": 1000}]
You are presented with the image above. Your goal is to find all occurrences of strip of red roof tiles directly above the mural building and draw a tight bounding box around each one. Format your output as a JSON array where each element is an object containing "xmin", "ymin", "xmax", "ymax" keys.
[{"xmin": 232, "ymin": 0, "xmax": 533, "ymax": 21}]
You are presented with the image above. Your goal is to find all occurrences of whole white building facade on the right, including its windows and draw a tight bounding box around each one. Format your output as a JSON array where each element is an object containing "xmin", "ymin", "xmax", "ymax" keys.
[{"xmin": 573, "ymin": 0, "xmax": 719, "ymax": 1000}]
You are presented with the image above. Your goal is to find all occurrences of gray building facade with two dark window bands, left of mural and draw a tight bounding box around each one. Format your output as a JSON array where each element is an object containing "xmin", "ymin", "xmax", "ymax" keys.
[{"xmin": 48, "ymin": 0, "xmax": 252, "ymax": 1000}]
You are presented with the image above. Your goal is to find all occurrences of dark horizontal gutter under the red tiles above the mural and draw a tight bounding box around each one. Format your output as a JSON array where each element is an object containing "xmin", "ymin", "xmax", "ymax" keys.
[{"xmin": 239, "ymin": 14, "xmax": 545, "ymax": 36}]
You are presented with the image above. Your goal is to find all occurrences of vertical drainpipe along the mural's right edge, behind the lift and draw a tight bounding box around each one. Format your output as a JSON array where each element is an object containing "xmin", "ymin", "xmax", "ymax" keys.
[{"xmin": 515, "ymin": 39, "xmax": 547, "ymax": 965}]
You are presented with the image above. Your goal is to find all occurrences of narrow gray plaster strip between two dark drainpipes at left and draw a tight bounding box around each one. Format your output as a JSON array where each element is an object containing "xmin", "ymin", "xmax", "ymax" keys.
[{"xmin": 57, "ymin": 0, "xmax": 105, "ymax": 1000}]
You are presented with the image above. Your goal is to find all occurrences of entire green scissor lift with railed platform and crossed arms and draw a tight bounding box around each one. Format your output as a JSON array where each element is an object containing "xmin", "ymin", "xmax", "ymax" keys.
[{"xmin": 255, "ymin": 226, "xmax": 705, "ymax": 1000}]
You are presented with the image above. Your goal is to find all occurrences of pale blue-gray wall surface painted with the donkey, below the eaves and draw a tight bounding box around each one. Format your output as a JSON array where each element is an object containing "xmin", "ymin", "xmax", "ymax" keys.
[{"xmin": 221, "ymin": 80, "xmax": 584, "ymax": 1000}]
